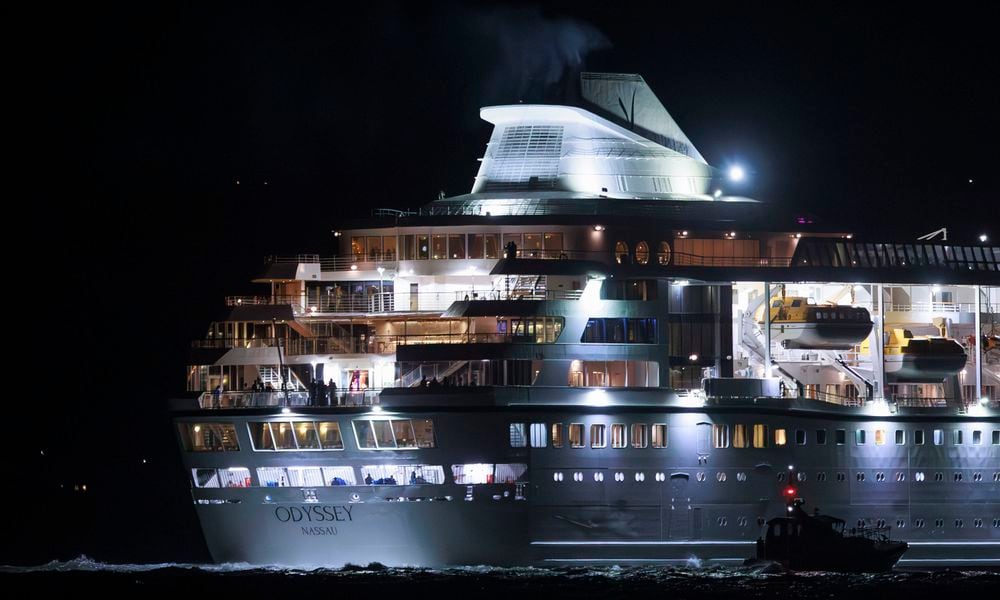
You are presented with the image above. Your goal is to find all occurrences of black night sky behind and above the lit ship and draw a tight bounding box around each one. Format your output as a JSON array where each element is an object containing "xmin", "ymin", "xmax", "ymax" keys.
[{"xmin": 0, "ymin": 2, "xmax": 1000, "ymax": 561}]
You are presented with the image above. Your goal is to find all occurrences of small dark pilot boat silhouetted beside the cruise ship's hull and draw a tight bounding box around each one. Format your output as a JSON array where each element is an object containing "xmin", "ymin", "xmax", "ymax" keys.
[{"xmin": 748, "ymin": 500, "xmax": 908, "ymax": 573}]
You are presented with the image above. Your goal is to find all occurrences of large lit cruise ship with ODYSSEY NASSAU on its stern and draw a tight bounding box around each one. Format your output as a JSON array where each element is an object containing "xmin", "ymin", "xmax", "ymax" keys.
[{"xmin": 171, "ymin": 73, "xmax": 1000, "ymax": 567}]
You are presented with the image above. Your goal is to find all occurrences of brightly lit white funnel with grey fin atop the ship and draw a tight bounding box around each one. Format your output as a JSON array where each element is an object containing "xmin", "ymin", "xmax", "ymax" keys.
[{"xmin": 433, "ymin": 73, "xmax": 746, "ymax": 214}]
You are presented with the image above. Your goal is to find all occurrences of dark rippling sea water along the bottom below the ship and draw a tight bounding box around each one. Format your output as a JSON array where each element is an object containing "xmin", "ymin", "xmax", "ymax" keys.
[{"xmin": 0, "ymin": 557, "xmax": 1000, "ymax": 600}]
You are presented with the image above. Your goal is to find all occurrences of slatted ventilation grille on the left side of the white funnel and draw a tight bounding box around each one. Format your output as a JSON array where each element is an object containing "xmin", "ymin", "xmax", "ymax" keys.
[{"xmin": 485, "ymin": 125, "xmax": 563, "ymax": 191}]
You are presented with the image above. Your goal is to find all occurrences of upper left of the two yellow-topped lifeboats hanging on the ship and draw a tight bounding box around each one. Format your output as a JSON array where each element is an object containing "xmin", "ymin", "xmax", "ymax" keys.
[{"xmin": 756, "ymin": 296, "xmax": 872, "ymax": 350}]
